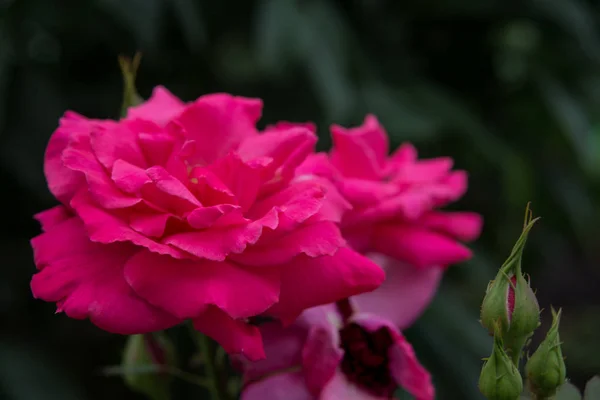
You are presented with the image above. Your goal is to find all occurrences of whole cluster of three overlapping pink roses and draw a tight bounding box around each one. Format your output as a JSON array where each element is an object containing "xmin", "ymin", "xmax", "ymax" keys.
[{"xmin": 31, "ymin": 87, "xmax": 482, "ymax": 400}]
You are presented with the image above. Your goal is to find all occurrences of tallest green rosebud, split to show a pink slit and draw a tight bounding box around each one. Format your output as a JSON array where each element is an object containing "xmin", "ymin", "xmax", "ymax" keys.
[{"xmin": 481, "ymin": 208, "xmax": 540, "ymax": 361}]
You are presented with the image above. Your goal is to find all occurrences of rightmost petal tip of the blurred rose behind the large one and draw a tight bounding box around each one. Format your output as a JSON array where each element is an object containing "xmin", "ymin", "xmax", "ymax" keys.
[{"xmin": 420, "ymin": 211, "xmax": 483, "ymax": 242}]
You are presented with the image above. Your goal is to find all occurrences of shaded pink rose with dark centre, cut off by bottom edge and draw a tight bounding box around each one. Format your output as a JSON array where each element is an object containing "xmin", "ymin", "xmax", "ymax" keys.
[{"xmin": 238, "ymin": 301, "xmax": 434, "ymax": 400}]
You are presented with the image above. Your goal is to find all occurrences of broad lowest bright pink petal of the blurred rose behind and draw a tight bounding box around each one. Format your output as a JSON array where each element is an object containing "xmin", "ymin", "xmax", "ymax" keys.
[{"xmin": 372, "ymin": 224, "xmax": 472, "ymax": 268}]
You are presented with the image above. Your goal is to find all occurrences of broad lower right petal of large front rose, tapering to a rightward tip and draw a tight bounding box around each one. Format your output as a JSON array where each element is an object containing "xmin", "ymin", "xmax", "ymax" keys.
[{"xmin": 267, "ymin": 247, "xmax": 385, "ymax": 324}]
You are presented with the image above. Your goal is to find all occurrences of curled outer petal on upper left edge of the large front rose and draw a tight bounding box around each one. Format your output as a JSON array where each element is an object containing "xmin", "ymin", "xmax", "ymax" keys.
[{"xmin": 44, "ymin": 111, "xmax": 94, "ymax": 204}]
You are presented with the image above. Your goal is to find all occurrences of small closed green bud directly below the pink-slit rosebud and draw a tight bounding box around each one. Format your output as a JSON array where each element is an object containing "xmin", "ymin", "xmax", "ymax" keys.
[{"xmin": 479, "ymin": 326, "xmax": 523, "ymax": 400}]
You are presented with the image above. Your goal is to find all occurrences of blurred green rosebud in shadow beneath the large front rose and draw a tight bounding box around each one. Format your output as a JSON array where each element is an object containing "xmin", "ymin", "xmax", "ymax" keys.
[{"xmin": 121, "ymin": 332, "xmax": 175, "ymax": 400}]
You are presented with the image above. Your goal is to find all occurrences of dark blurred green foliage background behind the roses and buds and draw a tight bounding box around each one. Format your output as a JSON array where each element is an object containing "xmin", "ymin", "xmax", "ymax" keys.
[{"xmin": 0, "ymin": 0, "xmax": 600, "ymax": 400}]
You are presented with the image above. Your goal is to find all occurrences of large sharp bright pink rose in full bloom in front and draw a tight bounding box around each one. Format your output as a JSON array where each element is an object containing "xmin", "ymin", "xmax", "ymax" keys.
[{"xmin": 31, "ymin": 87, "xmax": 384, "ymax": 359}]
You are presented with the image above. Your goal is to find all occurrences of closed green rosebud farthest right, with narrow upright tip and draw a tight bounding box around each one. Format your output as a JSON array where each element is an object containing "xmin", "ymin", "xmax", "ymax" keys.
[{"xmin": 525, "ymin": 309, "xmax": 567, "ymax": 398}]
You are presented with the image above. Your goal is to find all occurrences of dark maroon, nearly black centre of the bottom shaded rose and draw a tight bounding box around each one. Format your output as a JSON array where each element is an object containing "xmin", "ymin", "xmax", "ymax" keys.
[{"xmin": 340, "ymin": 323, "xmax": 397, "ymax": 398}]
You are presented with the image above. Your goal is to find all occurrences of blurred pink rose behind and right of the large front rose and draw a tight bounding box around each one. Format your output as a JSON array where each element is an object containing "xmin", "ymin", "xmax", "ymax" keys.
[{"xmin": 298, "ymin": 115, "xmax": 482, "ymax": 328}]
